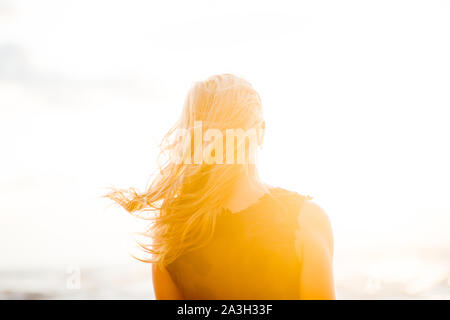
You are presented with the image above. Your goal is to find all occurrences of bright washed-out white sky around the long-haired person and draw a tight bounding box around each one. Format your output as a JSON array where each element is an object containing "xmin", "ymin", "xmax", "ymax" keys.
[{"xmin": 0, "ymin": 0, "xmax": 450, "ymax": 267}]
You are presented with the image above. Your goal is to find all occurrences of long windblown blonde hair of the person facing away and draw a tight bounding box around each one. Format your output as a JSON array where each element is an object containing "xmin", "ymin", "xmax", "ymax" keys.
[{"xmin": 107, "ymin": 74, "xmax": 263, "ymax": 265}]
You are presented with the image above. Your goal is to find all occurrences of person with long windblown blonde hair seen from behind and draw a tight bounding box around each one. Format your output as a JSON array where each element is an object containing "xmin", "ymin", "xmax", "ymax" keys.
[{"xmin": 108, "ymin": 74, "xmax": 335, "ymax": 299}]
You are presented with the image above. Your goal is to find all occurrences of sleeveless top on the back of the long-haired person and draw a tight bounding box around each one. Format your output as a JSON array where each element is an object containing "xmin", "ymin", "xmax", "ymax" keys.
[{"xmin": 167, "ymin": 188, "xmax": 305, "ymax": 300}]
